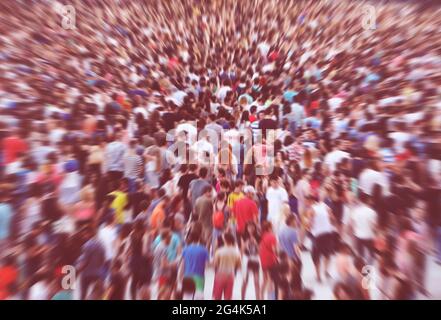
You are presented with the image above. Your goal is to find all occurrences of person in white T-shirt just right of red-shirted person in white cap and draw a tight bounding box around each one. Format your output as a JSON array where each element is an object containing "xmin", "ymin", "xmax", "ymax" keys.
[{"xmin": 266, "ymin": 176, "xmax": 288, "ymax": 229}]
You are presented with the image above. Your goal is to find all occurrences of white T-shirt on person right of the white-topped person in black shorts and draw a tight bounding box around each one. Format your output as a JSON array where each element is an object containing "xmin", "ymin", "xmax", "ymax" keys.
[{"xmin": 350, "ymin": 204, "xmax": 377, "ymax": 240}]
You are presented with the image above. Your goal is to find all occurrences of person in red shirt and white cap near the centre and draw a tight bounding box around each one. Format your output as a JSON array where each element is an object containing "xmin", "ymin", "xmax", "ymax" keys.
[{"xmin": 232, "ymin": 186, "xmax": 259, "ymax": 243}]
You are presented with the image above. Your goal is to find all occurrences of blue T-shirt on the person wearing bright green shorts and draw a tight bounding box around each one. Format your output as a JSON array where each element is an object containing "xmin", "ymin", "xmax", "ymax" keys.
[{"xmin": 182, "ymin": 244, "xmax": 208, "ymax": 277}]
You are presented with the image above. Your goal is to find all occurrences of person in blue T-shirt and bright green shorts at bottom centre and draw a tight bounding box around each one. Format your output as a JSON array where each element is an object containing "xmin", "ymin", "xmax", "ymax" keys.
[{"xmin": 181, "ymin": 231, "xmax": 209, "ymax": 297}]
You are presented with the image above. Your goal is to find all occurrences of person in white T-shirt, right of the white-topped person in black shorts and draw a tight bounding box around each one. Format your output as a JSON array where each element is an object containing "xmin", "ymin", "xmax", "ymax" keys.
[{"xmin": 349, "ymin": 193, "xmax": 378, "ymax": 263}]
